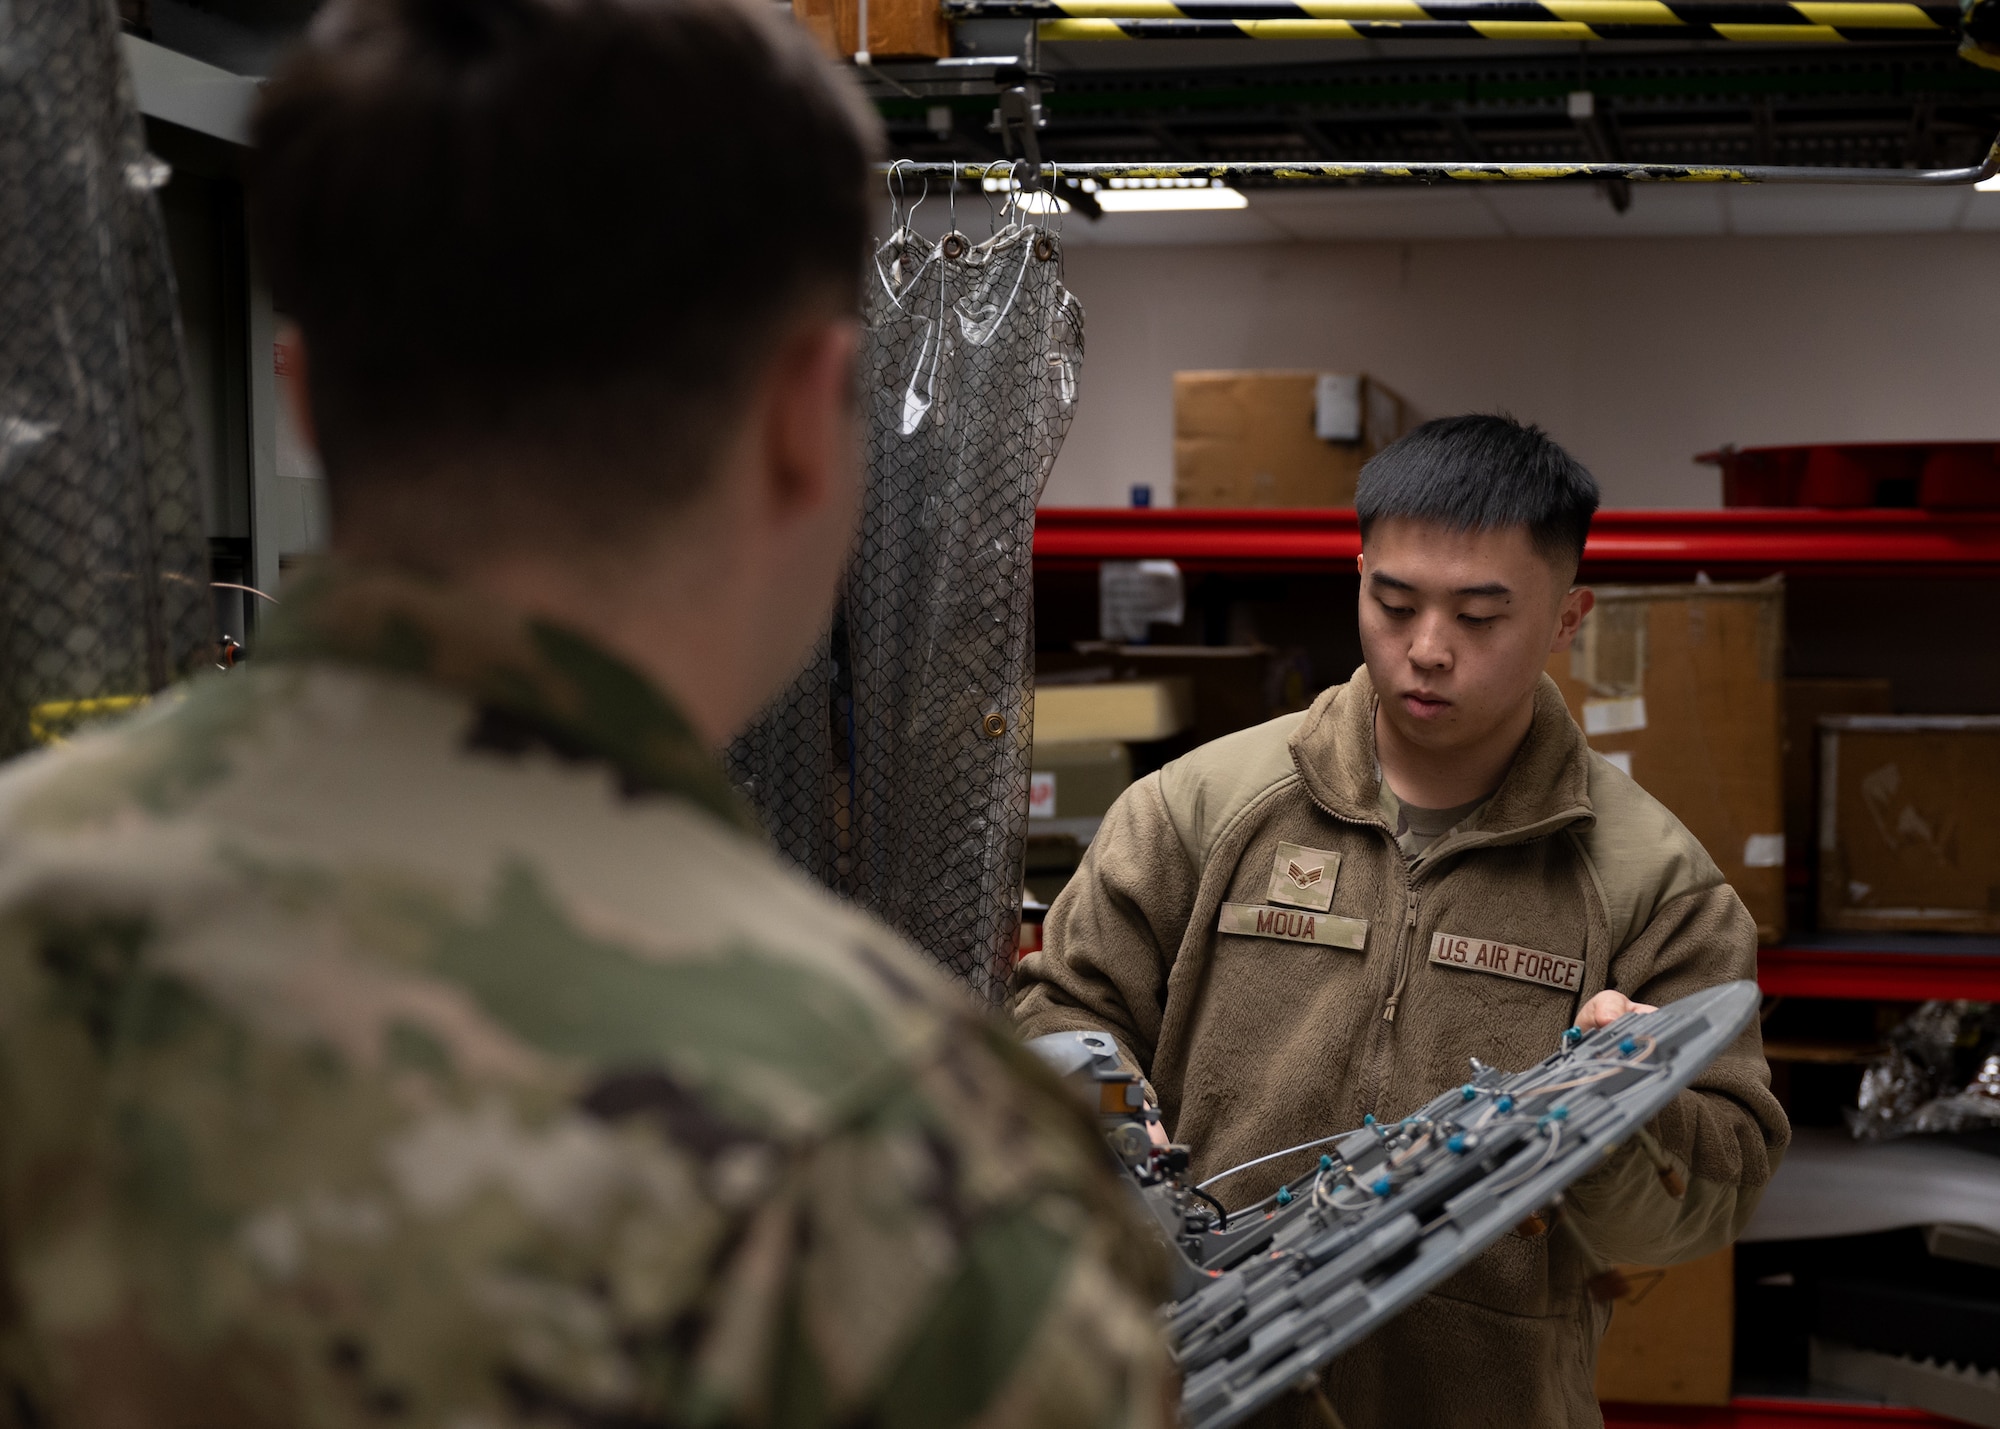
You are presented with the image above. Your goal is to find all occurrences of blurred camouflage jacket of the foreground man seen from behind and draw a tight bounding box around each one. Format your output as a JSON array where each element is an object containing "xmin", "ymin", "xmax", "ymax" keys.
[{"xmin": 0, "ymin": 566, "xmax": 1168, "ymax": 1429}]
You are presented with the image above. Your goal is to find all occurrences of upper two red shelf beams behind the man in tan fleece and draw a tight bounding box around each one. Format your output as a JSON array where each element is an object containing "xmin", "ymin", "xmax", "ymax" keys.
[{"xmin": 1034, "ymin": 506, "xmax": 2000, "ymax": 1001}]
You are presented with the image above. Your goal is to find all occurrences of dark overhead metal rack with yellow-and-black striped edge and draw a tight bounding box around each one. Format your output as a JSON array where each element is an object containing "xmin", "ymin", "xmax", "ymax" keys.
[{"xmin": 880, "ymin": 0, "xmax": 2000, "ymax": 177}]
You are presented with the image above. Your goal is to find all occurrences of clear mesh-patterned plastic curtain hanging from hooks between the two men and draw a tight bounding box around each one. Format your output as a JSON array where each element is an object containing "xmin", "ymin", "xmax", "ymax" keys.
[{"xmin": 732, "ymin": 224, "xmax": 1084, "ymax": 999}]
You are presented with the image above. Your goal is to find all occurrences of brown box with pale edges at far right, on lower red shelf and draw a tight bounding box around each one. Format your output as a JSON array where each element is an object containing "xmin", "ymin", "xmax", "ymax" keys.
[{"xmin": 1820, "ymin": 715, "xmax": 2000, "ymax": 933}]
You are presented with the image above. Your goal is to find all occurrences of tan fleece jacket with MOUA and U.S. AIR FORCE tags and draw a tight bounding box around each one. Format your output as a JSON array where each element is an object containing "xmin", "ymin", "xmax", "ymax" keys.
[{"xmin": 1012, "ymin": 670, "xmax": 1790, "ymax": 1429}]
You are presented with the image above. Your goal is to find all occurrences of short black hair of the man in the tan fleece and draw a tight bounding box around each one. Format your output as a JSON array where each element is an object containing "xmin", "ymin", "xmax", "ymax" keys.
[{"xmin": 1354, "ymin": 414, "xmax": 1598, "ymax": 568}]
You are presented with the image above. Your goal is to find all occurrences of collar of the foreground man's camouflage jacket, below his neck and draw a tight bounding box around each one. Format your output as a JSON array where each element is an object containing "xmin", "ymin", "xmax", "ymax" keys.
[{"xmin": 256, "ymin": 558, "xmax": 758, "ymax": 833}]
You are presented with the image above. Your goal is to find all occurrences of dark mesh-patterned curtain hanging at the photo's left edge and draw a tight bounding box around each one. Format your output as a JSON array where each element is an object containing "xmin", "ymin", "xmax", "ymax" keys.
[{"xmin": 0, "ymin": 0, "xmax": 210, "ymax": 755}]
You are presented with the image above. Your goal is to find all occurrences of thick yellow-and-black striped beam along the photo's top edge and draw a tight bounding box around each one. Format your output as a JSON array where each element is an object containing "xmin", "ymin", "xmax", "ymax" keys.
[{"xmin": 944, "ymin": 0, "xmax": 1958, "ymax": 44}]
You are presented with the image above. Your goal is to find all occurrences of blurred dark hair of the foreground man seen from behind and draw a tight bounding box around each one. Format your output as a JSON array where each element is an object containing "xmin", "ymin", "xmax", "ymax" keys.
[{"xmin": 252, "ymin": 0, "xmax": 880, "ymax": 540}]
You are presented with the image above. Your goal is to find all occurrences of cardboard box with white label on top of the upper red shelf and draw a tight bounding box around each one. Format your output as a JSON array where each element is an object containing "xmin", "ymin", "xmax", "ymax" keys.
[{"xmin": 1174, "ymin": 372, "xmax": 1408, "ymax": 506}]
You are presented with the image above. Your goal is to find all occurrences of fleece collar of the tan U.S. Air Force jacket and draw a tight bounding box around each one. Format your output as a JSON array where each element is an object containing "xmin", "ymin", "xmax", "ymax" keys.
[{"xmin": 1292, "ymin": 666, "xmax": 1596, "ymax": 847}]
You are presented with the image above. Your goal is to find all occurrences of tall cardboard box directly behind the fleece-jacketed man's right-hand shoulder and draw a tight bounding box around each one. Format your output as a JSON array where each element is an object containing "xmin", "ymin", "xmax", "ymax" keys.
[{"xmin": 1548, "ymin": 578, "xmax": 1784, "ymax": 943}]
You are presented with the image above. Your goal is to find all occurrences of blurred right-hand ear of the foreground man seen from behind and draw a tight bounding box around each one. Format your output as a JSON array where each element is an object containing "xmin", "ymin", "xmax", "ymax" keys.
[{"xmin": 764, "ymin": 318, "xmax": 862, "ymax": 514}]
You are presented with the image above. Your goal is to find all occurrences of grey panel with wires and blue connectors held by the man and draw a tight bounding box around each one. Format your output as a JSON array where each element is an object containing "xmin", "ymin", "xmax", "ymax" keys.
[{"xmin": 1032, "ymin": 983, "xmax": 1760, "ymax": 1429}]
